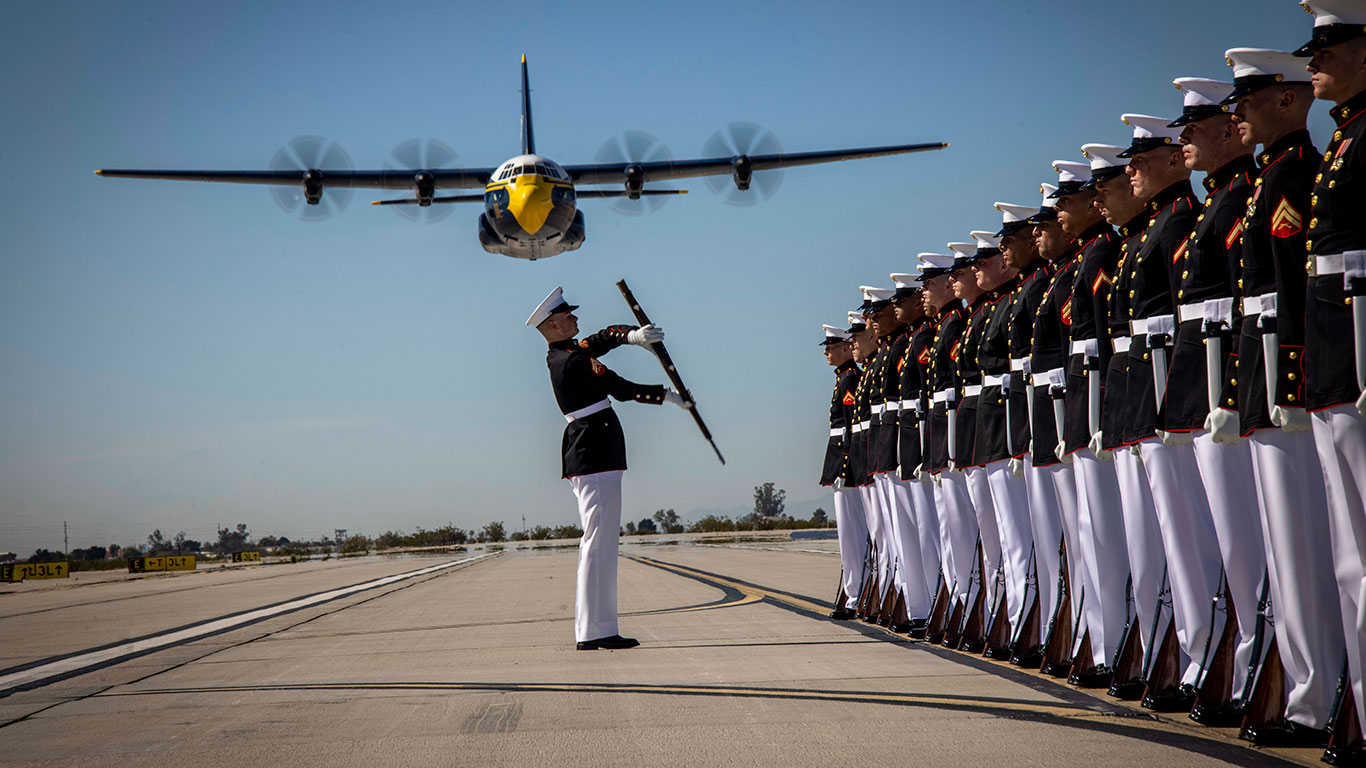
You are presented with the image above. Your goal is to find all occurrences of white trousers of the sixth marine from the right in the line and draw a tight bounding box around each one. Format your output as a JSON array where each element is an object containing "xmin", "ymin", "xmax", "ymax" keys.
[{"xmin": 1072, "ymin": 448, "xmax": 1130, "ymax": 666}]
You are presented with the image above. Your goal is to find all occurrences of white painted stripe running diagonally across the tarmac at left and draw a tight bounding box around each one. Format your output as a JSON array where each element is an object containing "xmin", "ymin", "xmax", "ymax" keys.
[{"xmin": 0, "ymin": 553, "xmax": 493, "ymax": 696}]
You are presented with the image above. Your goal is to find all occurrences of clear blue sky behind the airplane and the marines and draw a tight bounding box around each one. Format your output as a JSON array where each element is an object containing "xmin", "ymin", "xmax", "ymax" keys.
[{"xmin": 0, "ymin": 0, "xmax": 1328, "ymax": 555}]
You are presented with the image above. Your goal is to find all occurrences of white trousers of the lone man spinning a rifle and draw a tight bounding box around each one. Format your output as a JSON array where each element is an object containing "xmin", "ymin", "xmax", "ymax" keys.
[{"xmin": 570, "ymin": 470, "xmax": 624, "ymax": 642}]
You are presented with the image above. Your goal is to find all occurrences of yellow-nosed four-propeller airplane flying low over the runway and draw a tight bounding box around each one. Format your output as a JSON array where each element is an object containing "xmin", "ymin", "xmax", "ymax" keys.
[{"xmin": 96, "ymin": 53, "xmax": 948, "ymax": 261}]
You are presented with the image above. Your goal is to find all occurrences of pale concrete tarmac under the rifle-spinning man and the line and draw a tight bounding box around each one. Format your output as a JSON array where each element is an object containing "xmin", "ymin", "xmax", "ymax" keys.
[{"xmin": 0, "ymin": 537, "xmax": 1318, "ymax": 768}]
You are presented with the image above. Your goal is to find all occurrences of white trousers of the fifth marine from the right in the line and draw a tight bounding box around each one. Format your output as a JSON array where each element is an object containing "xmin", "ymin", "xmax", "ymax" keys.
[{"xmin": 1115, "ymin": 447, "xmax": 1167, "ymax": 664}]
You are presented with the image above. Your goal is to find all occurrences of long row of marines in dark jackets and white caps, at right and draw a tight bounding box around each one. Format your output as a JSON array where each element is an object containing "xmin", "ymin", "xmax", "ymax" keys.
[{"xmin": 821, "ymin": 0, "xmax": 1366, "ymax": 765}]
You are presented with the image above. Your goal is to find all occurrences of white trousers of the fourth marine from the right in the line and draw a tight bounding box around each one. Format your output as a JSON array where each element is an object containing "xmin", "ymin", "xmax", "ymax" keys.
[{"xmin": 1138, "ymin": 437, "xmax": 1224, "ymax": 685}]
